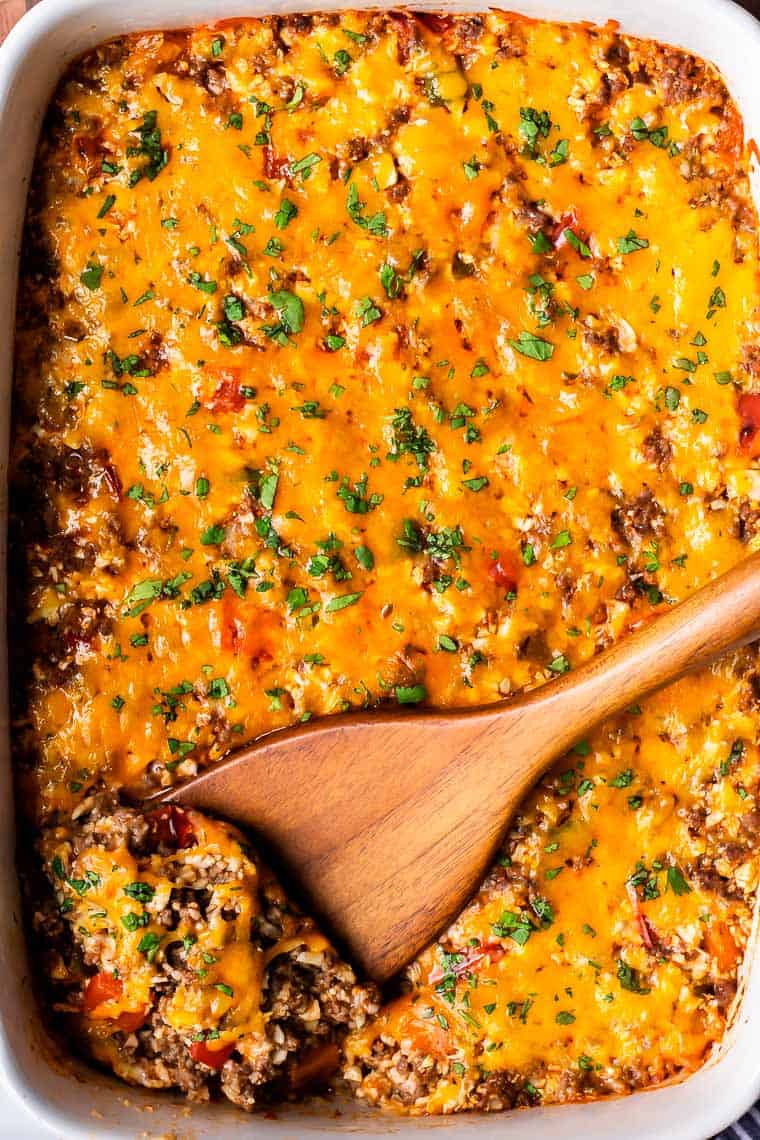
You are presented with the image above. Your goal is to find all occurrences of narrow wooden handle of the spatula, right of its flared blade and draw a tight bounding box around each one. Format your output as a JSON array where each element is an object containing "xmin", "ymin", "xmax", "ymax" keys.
[{"xmin": 508, "ymin": 552, "xmax": 760, "ymax": 766}]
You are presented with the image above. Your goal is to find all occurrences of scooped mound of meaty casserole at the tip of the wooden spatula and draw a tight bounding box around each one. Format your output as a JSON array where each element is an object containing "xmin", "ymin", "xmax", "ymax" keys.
[{"xmin": 36, "ymin": 795, "xmax": 378, "ymax": 1109}]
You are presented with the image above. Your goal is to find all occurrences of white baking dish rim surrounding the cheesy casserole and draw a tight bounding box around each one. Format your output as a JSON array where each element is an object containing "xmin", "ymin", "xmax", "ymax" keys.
[{"xmin": 0, "ymin": 0, "xmax": 760, "ymax": 1140}]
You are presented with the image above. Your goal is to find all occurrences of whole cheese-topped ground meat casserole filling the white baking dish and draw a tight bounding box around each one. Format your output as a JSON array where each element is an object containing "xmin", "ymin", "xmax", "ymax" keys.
[{"xmin": 10, "ymin": 0, "xmax": 760, "ymax": 1113}]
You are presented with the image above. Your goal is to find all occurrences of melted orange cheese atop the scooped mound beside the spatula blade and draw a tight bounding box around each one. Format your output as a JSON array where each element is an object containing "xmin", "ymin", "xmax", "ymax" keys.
[{"xmin": 44, "ymin": 813, "xmax": 273, "ymax": 1050}]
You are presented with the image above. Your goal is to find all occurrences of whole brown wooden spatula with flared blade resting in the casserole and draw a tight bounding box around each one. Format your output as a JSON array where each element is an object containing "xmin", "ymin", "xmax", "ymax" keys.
[{"xmin": 152, "ymin": 553, "xmax": 760, "ymax": 980}]
